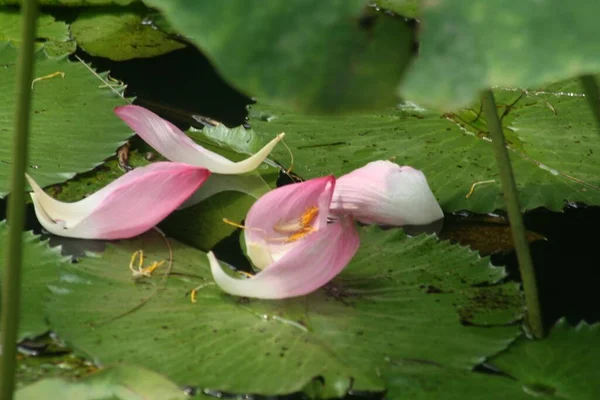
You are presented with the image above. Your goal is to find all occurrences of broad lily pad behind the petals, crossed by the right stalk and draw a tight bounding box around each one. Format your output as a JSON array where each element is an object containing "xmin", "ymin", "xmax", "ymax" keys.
[{"xmin": 232, "ymin": 81, "xmax": 600, "ymax": 213}]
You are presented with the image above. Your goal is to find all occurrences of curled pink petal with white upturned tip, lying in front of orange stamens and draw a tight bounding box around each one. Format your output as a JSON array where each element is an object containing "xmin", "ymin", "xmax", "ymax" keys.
[{"xmin": 208, "ymin": 217, "xmax": 359, "ymax": 299}]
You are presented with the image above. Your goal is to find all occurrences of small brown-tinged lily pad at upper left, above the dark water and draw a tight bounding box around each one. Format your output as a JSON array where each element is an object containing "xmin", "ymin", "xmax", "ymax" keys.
[{"xmin": 71, "ymin": 6, "xmax": 185, "ymax": 61}]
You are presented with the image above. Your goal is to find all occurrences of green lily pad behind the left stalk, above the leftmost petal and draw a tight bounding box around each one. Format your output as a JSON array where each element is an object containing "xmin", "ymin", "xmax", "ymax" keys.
[{"xmin": 0, "ymin": 43, "xmax": 132, "ymax": 198}]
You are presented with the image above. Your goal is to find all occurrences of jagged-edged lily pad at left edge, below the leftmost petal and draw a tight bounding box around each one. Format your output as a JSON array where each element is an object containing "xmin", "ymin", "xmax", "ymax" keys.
[{"xmin": 0, "ymin": 221, "xmax": 69, "ymax": 340}]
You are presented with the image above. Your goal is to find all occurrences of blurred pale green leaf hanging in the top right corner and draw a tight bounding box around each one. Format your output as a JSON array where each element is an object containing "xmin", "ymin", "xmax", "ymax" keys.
[{"xmin": 400, "ymin": 0, "xmax": 600, "ymax": 110}]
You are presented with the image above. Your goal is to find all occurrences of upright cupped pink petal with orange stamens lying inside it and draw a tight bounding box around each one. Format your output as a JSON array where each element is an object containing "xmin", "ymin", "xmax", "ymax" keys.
[{"xmin": 244, "ymin": 176, "xmax": 335, "ymax": 269}]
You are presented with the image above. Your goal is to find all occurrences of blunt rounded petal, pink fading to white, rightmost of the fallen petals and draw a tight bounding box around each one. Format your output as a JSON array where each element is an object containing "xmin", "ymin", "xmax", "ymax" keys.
[{"xmin": 331, "ymin": 161, "xmax": 444, "ymax": 226}]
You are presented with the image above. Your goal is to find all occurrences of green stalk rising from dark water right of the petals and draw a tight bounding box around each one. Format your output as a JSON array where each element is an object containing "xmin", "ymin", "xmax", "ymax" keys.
[{"xmin": 481, "ymin": 90, "xmax": 544, "ymax": 338}]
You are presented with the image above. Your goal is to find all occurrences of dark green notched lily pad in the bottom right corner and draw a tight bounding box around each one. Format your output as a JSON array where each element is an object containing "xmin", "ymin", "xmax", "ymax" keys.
[{"xmin": 383, "ymin": 320, "xmax": 600, "ymax": 400}]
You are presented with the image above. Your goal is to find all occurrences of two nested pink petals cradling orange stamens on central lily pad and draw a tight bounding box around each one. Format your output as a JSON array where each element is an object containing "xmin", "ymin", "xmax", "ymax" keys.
[{"xmin": 208, "ymin": 176, "xmax": 359, "ymax": 299}]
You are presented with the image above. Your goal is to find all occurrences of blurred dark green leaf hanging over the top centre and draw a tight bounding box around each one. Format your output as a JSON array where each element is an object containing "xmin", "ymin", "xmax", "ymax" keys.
[{"xmin": 145, "ymin": 0, "xmax": 413, "ymax": 112}]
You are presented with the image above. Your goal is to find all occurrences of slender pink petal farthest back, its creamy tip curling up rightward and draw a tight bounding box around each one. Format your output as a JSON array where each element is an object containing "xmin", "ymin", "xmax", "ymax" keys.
[{"xmin": 115, "ymin": 105, "xmax": 284, "ymax": 175}]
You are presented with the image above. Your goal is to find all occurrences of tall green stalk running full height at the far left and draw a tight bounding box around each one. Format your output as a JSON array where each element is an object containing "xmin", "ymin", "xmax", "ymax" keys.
[{"xmin": 0, "ymin": 0, "xmax": 37, "ymax": 400}]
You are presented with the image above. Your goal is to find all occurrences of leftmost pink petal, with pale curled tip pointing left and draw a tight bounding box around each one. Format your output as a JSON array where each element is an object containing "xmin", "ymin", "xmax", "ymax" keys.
[{"xmin": 27, "ymin": 162, "xmax": 210, "ymax": 240}]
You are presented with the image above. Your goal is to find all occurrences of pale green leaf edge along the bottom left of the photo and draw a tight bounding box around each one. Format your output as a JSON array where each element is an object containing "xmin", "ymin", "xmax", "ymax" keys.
[{"xmin": 15, "ymin": 366, "xmax": 188, "ymax": 400}]
